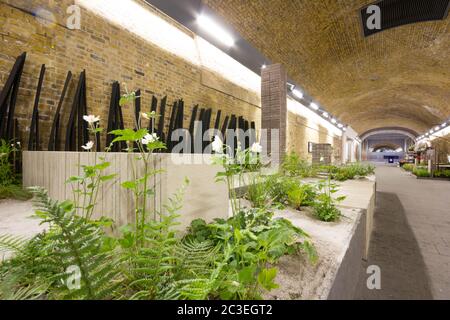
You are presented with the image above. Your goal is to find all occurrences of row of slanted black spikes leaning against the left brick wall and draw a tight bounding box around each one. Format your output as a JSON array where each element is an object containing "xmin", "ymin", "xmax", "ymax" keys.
[{"xmin": 0, "ymin": 53, "xmax": 256, "ymax": 152}]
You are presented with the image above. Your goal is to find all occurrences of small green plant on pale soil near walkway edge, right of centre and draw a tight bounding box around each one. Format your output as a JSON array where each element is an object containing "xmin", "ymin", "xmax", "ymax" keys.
[{"xmin": 314, "ymin": 178, "xmax": 346, "ymax": 222}]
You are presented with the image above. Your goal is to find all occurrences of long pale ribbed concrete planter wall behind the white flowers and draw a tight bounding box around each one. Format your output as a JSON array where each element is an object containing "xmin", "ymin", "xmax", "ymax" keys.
[{"xmin": 23, "ymin": 151, "xmax": 228, "ymax": 230}]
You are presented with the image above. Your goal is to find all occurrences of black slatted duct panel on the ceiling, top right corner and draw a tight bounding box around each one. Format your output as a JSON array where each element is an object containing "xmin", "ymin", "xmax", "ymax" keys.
[{"xmin": 361, "ymin": 0, "xmax": 450, "ymax": 37}]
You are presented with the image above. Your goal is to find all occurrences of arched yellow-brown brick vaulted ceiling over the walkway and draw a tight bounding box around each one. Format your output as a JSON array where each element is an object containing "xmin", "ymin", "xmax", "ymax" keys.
[{"xmin": 203, "ymin": 0, "xmax": 450, "ymax": 133}]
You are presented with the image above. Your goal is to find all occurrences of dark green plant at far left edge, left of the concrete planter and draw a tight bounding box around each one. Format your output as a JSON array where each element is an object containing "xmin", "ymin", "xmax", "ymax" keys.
[{"xmin": 0, "ymin": 140, "xmax": 31, "ymax": 200}]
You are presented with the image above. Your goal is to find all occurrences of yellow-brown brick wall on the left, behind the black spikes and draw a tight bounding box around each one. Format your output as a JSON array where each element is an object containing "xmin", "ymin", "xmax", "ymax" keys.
[{"xmin": 0, "ymin": 0, "xmax": 260, "ymax": 149}]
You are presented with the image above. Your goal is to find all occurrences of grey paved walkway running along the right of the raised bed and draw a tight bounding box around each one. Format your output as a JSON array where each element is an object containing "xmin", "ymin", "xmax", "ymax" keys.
[{"xmin": 355, "ymin": 166, "xmax": 450, "ymax": 299}]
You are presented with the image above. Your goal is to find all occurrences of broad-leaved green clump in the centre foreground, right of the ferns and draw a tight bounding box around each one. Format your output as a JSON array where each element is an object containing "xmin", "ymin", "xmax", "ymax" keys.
[{"xmin": 186, "ymin": 209, "xmax": 317, "ymax": 299}]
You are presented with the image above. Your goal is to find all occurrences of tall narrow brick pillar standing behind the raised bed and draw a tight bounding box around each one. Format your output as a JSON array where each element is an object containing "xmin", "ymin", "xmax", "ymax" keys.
[{"xmin": 261, "ymin": 64, "xmax": 287, "ymax": 166}]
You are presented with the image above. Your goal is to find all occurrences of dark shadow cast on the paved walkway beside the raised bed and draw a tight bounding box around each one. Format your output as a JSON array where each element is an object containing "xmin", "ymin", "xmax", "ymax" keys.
[{"xmin": 355, "ymin": 192, "xmax": 433, "ymax": 300}]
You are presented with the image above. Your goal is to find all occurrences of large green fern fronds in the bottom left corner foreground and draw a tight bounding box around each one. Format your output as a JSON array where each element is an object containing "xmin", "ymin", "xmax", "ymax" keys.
[{"xmin": 0, "ymin": 188, "xmax": 120, "ymax": 299}]
